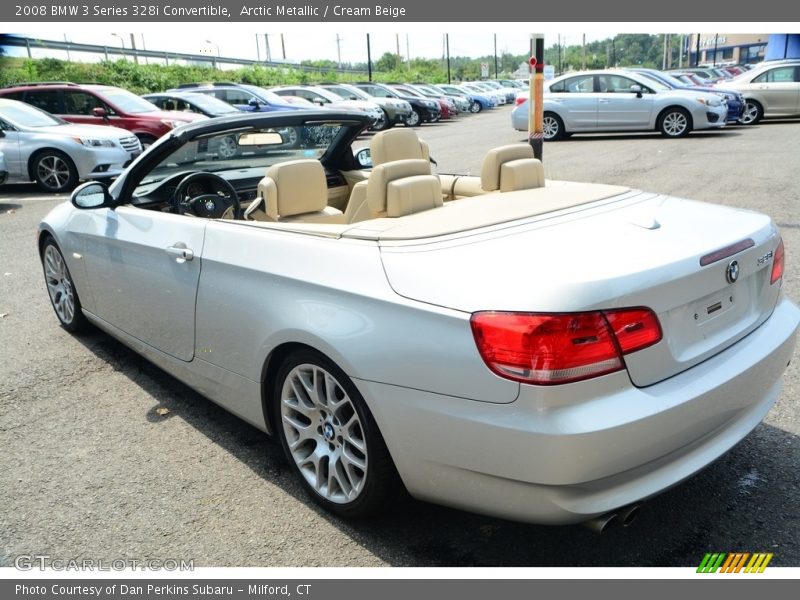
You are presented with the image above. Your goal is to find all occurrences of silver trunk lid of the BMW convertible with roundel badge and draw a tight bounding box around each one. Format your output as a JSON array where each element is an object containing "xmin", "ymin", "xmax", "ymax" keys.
[{"xmin": 379, "ymin": 194, "xmax": 780, "ymax": 386}]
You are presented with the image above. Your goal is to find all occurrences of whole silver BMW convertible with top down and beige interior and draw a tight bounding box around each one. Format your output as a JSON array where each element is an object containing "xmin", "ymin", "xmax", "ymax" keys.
[{"xmin": 39, "ymin": 110, "xmax": 800, "ymax": 523}]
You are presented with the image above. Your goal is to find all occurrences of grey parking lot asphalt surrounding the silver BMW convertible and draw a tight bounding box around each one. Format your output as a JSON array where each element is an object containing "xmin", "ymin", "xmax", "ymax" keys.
[{"xmin": 0, "ymin": 107, "xmax": 800, "ymax": 567}]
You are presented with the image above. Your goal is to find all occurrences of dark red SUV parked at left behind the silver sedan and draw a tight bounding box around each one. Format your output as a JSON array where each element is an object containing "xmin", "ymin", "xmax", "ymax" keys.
[{"xmin": 0, "ymin": 82, "xmax": 206, "ymax": 147}]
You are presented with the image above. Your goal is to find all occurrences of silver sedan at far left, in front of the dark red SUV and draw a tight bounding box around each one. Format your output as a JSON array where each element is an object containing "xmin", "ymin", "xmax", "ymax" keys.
[{"xmin": 0, "ymin": 98, "xmax": 142, "ymax": 193}]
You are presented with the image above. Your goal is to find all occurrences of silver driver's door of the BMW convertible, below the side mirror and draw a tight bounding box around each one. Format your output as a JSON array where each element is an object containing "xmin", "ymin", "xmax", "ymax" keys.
[{"xmin": 83, "ymin": 205, "xmax": 206, "ymax": 361}]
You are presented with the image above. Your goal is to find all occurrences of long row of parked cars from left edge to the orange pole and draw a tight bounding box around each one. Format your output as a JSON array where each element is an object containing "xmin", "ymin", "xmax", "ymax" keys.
[{"xmin": 0, "ymin": 80, "xmax": 521, "ymax": 193}]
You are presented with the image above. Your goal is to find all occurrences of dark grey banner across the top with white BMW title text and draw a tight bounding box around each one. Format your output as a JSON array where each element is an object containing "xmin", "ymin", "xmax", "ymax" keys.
[{"xmin": 0, "ymin": 0, "xmax": 800, "ymax": 22}]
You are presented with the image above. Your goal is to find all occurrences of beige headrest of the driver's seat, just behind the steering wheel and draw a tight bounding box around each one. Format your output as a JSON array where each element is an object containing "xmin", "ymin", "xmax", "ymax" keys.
[{"xmin": 258, "ymin": 159, "xmax": 328, "ymax": 220}]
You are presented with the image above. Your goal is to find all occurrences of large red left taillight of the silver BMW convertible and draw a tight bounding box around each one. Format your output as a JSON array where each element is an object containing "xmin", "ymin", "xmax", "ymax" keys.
[{"xmin": 470, "ymin": 308, "xmax": 662, "ymax": 385}]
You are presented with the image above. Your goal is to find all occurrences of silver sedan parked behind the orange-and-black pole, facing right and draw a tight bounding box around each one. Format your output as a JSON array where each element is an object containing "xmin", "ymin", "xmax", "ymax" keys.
[{"xmin": 511, "ymin": 70, "xmax": 728, "ymax": 140}]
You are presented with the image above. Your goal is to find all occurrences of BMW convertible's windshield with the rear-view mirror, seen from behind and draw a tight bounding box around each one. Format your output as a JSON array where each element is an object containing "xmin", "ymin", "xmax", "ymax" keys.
[{"xmin": 133, "ymin": 122, "xmax": 347, "ymax": 193}]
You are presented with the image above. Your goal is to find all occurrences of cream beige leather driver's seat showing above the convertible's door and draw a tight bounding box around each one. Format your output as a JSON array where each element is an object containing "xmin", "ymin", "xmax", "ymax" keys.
[{"xmin": 244, "ymin": 159, "xmax": 345, "ymax": 223}]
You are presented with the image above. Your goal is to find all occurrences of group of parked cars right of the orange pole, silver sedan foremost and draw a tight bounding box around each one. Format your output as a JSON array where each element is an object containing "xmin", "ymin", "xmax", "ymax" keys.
[{"xmin": 511, "ymin": 59, "xmax": 800, "ymax": 140}]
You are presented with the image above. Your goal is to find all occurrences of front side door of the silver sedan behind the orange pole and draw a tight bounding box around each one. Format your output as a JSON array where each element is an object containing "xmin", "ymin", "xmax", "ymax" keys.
[{"xmin": 597, "ymin": 74, "xmax": 655, "ymax": 130}]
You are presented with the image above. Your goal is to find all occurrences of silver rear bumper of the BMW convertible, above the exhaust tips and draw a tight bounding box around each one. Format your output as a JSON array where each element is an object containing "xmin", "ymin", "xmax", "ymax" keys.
[{"xmin": 356, "ymin": 300, "xmax": 800, "ymax": 523}]
